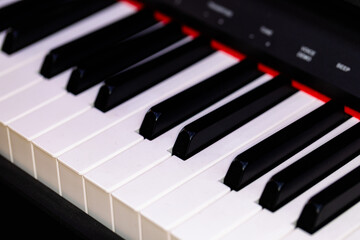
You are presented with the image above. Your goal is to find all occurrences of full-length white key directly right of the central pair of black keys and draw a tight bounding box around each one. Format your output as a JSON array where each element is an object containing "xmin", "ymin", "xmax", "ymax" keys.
[{"xmin": 106, "ymin": 93, "xmax": 315, "ymax": 239}]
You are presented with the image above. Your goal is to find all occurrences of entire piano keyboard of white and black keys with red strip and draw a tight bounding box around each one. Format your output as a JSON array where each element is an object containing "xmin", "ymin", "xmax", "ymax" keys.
[{"xmin": 0, "ymin": 0, "xmax": 360, "ymax": 240}]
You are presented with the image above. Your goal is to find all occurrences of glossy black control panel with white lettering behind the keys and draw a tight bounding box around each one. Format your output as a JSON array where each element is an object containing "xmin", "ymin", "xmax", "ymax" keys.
[{"xmin": 145, "ymin": 0, "xmax": 360, "ymax": 110}]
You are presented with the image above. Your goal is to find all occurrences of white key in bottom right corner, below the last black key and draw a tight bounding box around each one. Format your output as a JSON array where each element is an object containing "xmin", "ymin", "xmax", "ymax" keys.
[{"xmin": 283, "ymin": 202, "xmax": 360, "ymax": 240}]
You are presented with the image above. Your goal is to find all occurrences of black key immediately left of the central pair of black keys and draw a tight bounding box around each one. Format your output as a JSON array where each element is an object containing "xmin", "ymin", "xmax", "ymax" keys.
[{"xmin": 95, "ymin": 38, "xmax": 214, "ymax": 112}]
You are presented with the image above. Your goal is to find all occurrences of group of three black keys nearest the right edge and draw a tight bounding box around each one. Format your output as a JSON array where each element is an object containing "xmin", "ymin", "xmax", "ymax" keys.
[{"xmin": 224, "ymin": 101, "xmax": 360, "ymax": 233}]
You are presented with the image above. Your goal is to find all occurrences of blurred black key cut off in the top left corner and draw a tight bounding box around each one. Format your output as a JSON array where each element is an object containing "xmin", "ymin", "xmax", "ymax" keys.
[{"xmin": 0, "ymin": 0, "xmax": 51, "ymax": 31}]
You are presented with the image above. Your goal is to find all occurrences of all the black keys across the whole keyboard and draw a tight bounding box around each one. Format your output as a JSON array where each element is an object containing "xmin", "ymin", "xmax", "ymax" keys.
[{"xmin": 0, "ymin": 0, "xmax": 360, "ymax": 235}]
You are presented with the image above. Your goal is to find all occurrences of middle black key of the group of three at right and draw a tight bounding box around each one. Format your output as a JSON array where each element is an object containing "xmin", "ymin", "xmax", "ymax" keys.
[{"xmin": 259, "ymin": 123, "xmax": 360, "ymax": 211}]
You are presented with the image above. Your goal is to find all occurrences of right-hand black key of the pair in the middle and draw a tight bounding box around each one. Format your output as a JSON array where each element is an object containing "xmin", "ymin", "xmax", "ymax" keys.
[{"xmin": 172, "ymin": 76, "xmax": 297, "ymax": 160}]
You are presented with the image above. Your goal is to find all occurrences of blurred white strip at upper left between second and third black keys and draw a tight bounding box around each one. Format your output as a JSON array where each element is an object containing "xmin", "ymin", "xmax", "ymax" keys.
[{"xmin": 0, "ymin": 2, "xmax": 136, "ymax": 76}]
